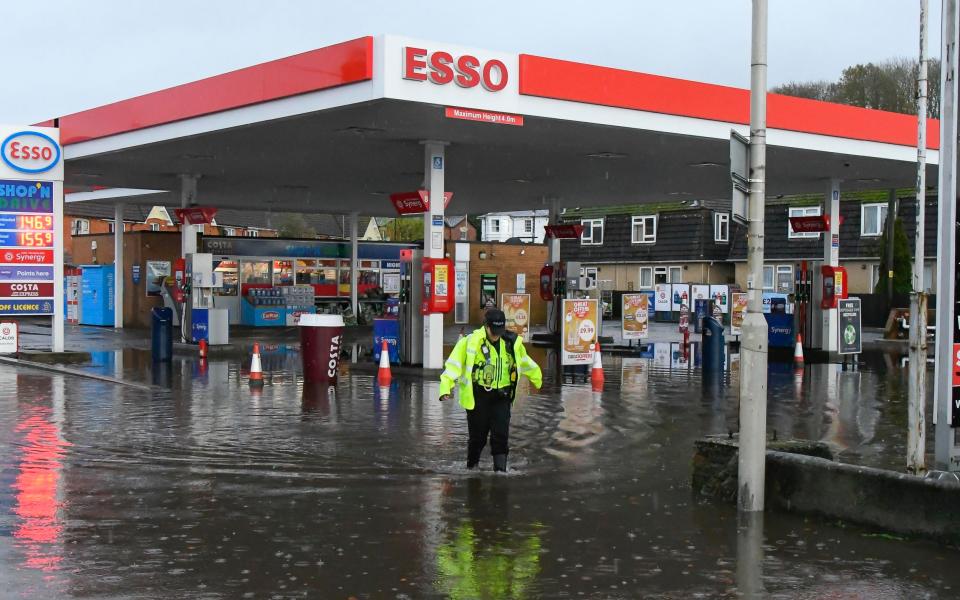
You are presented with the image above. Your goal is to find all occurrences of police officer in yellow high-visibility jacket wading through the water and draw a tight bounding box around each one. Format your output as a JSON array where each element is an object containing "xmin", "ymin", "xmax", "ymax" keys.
[{"xmin": 440, "ymin": 308, "xmax": 543, "ymax": 471}]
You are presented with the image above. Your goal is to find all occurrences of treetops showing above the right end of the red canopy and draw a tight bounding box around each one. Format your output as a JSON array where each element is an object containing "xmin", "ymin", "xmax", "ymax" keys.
[{"xmin": 770, "ymin": 58, "xmax": 940, "ymax": 118}]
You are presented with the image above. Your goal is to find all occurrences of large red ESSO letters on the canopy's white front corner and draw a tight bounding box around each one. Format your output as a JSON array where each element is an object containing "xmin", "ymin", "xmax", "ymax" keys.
[{"xmin": 403, "ymin": 46, "xmax": 509, "ymax": 92}]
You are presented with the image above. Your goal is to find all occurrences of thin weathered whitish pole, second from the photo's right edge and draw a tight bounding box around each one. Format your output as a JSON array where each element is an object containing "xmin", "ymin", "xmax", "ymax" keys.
[{"xmin": 908, "ymin": 0, "xmax": 927, "ymax": 475}]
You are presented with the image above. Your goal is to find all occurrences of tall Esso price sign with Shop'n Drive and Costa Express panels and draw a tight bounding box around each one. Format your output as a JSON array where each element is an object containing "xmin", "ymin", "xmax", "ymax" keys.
[{"xmin": 0, "ymin": 125, "xmax": 64, "ymax": 352}]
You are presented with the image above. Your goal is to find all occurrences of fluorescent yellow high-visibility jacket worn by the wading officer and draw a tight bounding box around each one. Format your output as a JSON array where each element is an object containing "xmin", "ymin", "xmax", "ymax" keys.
[{"xmin": 440, "ymin": 327, "xmax": 543, "ymax": 410}]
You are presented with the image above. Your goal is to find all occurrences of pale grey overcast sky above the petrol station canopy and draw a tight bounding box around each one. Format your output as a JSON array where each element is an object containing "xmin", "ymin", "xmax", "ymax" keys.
[{"xmin": 0, "ymin": 0, "xmax": 940, "ymax": 123}]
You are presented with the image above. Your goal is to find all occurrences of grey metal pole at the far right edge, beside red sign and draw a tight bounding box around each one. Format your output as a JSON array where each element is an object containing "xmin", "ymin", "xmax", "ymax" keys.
[{"xmin": 934, "ymin": 0, "xmax": 960, "ymax": 470}]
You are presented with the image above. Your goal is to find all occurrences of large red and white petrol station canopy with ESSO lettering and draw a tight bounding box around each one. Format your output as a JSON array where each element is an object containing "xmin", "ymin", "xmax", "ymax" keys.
[{"xmin": 50, "ymin": 35, "xmax": 939, "ymax": 216}]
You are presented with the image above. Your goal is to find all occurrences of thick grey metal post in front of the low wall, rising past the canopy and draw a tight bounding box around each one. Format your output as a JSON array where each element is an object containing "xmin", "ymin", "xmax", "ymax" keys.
[{"xmin": 737, "ymin": 0, "xmax": 767, "ymax": 512}]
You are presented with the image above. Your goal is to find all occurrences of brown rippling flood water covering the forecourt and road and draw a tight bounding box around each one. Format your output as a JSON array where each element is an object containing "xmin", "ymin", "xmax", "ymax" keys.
[{"xmin": 0, "ymin": 344, "xmax": 960, "ymax": 599}]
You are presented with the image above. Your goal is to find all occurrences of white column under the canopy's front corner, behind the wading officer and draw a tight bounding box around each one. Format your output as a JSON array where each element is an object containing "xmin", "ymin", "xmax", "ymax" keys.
[{"xmin": 423, "ymin": 141, "xmax": 447, "ymax": 369}]
